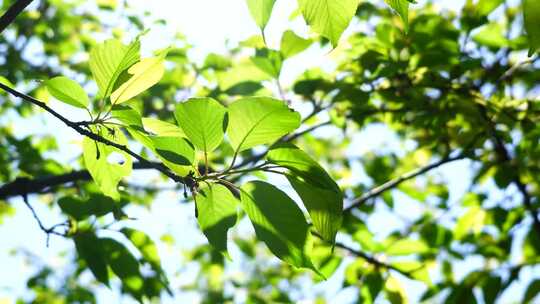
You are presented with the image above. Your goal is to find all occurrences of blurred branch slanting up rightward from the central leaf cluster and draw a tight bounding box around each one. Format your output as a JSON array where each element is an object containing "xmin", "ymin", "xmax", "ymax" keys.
[{"xmin": 343, "ymin": 153, "xmax": 466, "ymax": 212}]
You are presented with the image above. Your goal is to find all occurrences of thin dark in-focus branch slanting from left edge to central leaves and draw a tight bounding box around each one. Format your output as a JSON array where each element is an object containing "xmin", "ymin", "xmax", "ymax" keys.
[{"xmin": 0, "ymin": 83, "xmax": 185, "ymax": 183}]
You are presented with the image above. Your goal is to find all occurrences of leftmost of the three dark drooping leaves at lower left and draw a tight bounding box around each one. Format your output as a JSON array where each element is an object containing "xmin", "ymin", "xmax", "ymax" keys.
[{"xmin": 73, "ymin": 232, "xmax": 109, "ymax": 285}]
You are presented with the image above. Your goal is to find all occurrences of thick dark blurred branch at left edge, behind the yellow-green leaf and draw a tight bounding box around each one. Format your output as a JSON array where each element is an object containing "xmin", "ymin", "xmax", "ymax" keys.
[{"xmin": 0, "ymin": 162, "xmax": 165, "ymax": 200}]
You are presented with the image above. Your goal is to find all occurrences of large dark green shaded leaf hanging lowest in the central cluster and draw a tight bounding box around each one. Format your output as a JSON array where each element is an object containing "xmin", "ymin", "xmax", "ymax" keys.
[{"xmin": 241, "ymin": 181, "xmax": 314, "ymax": 269}]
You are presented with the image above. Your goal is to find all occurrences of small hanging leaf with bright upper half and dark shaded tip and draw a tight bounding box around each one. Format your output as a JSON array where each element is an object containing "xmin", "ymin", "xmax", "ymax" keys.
[{"xmin": 195, "ymin": 184, "xmax": 238, "ymax": 255}]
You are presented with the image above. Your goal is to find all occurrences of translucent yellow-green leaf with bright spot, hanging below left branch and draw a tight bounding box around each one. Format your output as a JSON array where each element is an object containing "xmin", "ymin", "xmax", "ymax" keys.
[{"xmin": 83, "ymin": 127, "xmax": 132, "ymax": 200}]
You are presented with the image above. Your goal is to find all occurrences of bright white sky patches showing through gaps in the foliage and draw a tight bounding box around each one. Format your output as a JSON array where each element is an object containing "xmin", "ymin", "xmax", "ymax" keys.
[{"xmin": 0, "ymin": 0, "xmax": 530, "ymax": 304}]
